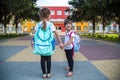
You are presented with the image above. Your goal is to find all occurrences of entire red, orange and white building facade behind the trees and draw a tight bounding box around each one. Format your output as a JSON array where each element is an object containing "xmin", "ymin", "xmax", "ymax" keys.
[{"xmin": 0, "ymin": 6, "xmax": 119, "ymax": 34}]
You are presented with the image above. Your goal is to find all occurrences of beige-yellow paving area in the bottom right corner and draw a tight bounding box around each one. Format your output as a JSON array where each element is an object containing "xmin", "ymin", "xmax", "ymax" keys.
[{"xmin": 91, "ymin": 60, "xmax": 120, "ymax": 80}]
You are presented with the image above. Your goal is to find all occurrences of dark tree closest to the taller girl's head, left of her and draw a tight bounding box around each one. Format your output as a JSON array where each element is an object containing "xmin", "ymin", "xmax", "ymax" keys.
[{"xmin": 11, "ymin": 0, "xmax": 39, "ymax": 33}]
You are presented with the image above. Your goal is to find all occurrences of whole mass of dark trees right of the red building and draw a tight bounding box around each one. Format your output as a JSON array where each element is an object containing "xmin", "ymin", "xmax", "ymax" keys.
[{"xmin": 68, "ymin": 0, "xmax": 120, "ymax": 38}]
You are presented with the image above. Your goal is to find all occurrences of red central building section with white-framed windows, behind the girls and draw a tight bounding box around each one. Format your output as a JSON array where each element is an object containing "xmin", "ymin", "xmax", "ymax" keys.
[{"xmin": 41, "ymin": 6, "xmax": 70, "ymax": 31}]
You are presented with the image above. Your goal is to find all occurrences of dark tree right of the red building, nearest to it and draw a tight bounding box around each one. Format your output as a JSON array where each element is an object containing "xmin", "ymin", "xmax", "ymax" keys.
[{"xmin": 69, "ymin": 0, "xmax": 97, "ymax": 34}]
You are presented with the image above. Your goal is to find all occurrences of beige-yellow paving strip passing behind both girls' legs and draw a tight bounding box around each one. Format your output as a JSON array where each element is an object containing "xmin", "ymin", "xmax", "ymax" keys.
[{"xmin": 6, "ymin": 46, "xmax": 87, "ymax": 62}]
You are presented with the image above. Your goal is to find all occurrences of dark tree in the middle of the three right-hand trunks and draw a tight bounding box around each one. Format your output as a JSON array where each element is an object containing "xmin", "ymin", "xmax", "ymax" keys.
[{"xmin": 95, "ymin": 0, "xmax": 112, "ymax": 34}]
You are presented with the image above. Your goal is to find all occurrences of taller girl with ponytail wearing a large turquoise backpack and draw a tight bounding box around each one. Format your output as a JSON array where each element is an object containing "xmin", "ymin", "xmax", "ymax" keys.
[{"xmin": 33, "ymin": 8, "xmax": 62, "ymax": 78}]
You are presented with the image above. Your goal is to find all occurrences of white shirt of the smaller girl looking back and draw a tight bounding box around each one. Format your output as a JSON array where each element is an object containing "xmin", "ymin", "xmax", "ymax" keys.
[{"xmin": 64, "ymin": 30, "xmax": 75, "ymax": 50}]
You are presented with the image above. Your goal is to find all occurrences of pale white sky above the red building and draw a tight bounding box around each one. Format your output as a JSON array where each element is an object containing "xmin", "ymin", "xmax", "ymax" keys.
[{"xmin": 36, "ymin": 0, "xmax": 69, "ymax": 6}]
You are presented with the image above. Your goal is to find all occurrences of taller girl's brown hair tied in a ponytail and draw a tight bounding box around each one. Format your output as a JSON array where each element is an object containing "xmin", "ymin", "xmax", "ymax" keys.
[{"xmin": 40, "ymin": 8, "xmax": 50, "ymax": 30}]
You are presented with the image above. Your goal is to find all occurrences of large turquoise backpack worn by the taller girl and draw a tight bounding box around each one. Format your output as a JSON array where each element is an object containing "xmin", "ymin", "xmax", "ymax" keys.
[{"xmin": 33, "ymin": 23, "xmax": 55, "ymax": 56}]
